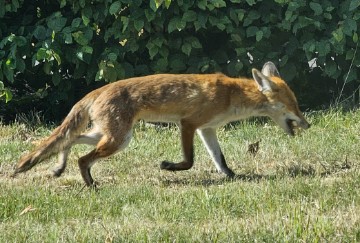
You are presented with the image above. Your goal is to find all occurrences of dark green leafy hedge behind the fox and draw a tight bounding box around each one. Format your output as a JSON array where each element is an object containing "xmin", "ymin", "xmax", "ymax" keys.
[{"xmin": 0, "ymin": 0, "xmax": 360, "ymax": 119}]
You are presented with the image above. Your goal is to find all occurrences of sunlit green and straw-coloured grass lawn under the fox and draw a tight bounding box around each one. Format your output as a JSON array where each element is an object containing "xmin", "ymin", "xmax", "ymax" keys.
[{"xmin": 0, "ymin": 110, "xmax": 360, "ymax": 242}]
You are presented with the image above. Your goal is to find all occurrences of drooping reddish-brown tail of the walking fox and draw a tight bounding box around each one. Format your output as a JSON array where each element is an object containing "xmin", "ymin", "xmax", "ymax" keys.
[{"xmin": 14, "ymin": 100, "xmax": 92, "ymax": 174}]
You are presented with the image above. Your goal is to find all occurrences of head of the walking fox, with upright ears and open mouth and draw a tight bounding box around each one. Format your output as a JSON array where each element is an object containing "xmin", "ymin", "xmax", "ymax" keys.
[{"xmin": 252, "ymin": 62, "xmax": 310, "ymax": 136}]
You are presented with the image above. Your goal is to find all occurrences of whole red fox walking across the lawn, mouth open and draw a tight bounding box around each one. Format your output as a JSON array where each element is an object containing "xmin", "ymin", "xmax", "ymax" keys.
[{"xmin": 14, "ymin": 62, "xmax": 310, "ymax": 186}]
